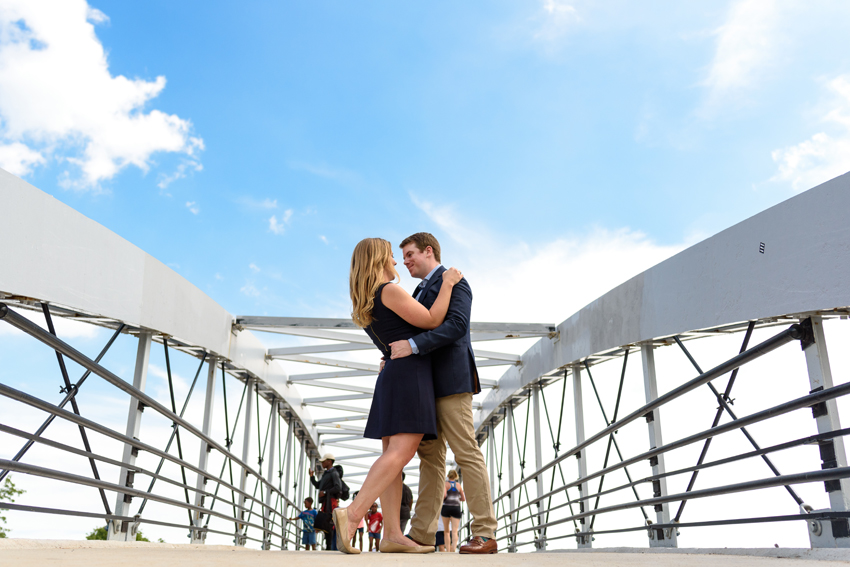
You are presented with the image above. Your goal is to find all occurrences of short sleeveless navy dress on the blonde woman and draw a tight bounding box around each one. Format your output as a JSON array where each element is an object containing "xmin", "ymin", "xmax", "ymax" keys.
[{"xmin": 363, "ymin": 284, "xmax": 437, "ymax": 439}]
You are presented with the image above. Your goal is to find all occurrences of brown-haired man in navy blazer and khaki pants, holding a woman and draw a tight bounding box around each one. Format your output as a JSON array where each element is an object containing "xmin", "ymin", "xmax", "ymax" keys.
[{"xmin": 390, "ymin": 232, "xmax": 497, "ymax": 554}]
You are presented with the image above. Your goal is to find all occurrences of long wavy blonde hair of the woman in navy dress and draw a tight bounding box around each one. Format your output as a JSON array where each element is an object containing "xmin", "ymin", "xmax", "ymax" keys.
[{"xmin": 348, "ymin": 238, "xmax": 399, "ymax": 327}]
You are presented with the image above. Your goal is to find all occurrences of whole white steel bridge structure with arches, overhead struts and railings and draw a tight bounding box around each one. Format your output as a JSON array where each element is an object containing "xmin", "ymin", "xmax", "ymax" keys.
[{"xmin": 0, "ymin": 171, "xmax": 850, "ymax": 550}]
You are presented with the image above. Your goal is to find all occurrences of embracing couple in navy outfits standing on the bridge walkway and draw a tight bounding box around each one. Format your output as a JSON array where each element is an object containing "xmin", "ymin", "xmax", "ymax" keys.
[{"xmin": 333, "ymin": 232, "xmax": 497, "ymax": 553}]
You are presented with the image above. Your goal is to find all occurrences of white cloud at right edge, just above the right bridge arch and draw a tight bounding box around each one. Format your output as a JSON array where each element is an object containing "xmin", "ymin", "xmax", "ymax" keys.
[{"xmin": 772, "ymin": 75, "xmax": 850, "ymax": 191}]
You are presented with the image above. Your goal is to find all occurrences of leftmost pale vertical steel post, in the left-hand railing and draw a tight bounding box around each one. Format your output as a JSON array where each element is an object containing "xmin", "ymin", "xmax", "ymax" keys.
[{"xmin": 106, "ymin": 331, "xmax": 153, "ymax": 541}]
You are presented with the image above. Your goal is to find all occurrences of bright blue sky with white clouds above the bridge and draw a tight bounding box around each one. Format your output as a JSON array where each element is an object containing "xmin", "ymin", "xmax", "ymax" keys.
[{"xmin": 0, "ymin": 0, "xmax": 850, "ymax": 321}]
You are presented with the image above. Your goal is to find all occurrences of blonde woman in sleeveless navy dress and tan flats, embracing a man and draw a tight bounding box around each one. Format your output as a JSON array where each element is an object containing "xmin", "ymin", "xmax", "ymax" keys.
[{"xmin": 333, "ymin": 238, "xmax": 463, "ymax": 553}]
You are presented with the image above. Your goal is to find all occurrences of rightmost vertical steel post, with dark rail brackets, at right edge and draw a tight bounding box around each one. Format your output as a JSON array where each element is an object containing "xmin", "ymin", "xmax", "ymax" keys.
[{"xmin": 802, "ymin": 316, "xmax": 850, "ymax": 547}]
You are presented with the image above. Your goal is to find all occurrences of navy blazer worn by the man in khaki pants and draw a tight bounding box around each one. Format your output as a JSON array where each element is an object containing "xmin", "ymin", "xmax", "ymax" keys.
[{"xmin": 413, "ymin": 266, "xmax": 481, "ymax": 398}]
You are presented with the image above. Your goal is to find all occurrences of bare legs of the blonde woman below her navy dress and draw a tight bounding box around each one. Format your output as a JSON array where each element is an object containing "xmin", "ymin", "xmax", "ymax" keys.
[{"xmin": 340, "ymin": 433, "xmax": 422, "ymax": 547}]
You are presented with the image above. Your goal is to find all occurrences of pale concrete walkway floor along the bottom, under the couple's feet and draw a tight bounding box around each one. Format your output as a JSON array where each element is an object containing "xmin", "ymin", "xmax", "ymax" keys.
[{"xmin": 0, "ymin": 539, "xmax": 850, "ymax": 567}]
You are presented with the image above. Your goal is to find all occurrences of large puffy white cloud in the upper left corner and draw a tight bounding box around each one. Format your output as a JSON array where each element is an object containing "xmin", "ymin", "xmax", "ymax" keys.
[{"xmin": 0, "ymin": 0, "xmax": 203, "ymax": 190}]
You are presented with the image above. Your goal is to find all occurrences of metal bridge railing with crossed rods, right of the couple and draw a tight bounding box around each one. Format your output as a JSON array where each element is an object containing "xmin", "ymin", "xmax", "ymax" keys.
[{"xmin": 464, "ymin": 316, "xmax": 850, "ymax": 551}]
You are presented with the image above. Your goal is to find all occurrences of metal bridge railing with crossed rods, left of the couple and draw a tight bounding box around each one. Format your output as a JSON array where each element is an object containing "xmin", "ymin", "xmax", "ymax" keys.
[{"xmin": 0, "ymin": 303, "xmax": 311, "ymax": 549}]
